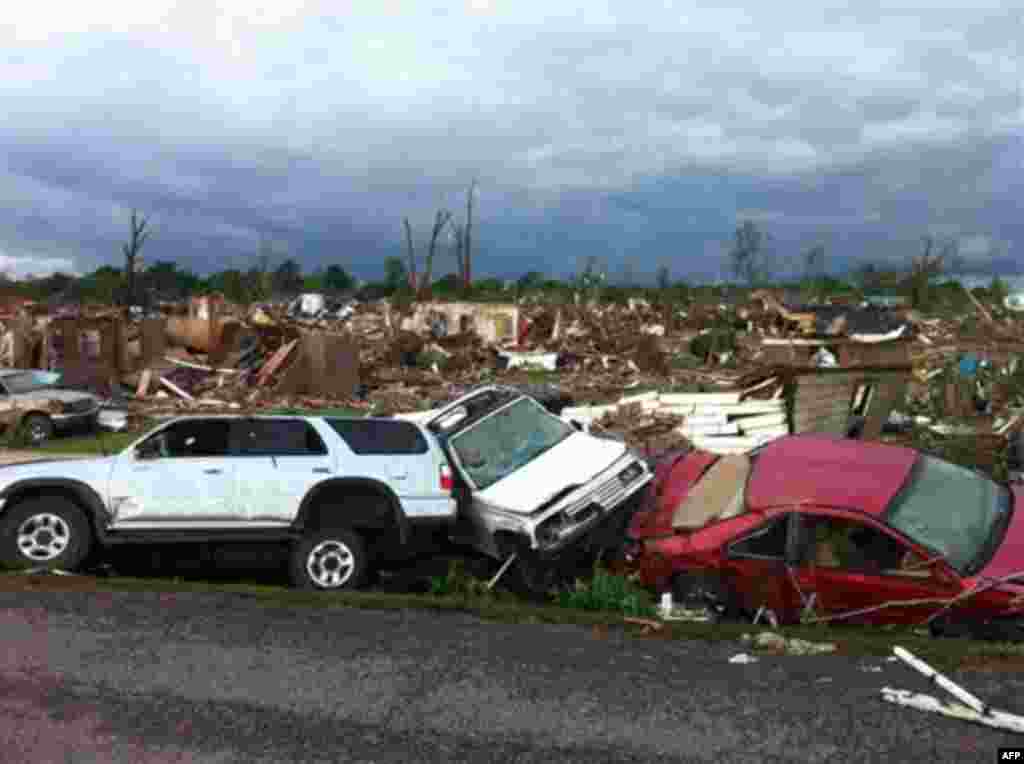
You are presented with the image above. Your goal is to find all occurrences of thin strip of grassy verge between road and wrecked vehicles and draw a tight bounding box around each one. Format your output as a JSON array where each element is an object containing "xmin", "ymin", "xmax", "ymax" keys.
[{"xmin": 0, "ymin": 572, "xmax": 1024, "ymax": 671}]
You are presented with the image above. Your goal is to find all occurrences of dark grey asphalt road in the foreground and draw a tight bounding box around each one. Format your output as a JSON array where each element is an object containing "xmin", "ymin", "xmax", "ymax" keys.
[{"xmin": 0, "ymin": 592, "xmax": 1024, "ymax": 764}]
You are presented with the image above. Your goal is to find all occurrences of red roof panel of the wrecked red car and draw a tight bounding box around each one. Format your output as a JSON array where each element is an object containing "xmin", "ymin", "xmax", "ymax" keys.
[{"xmin": 746, "ymin": 435, "xmax": 918, "ymax": 515}]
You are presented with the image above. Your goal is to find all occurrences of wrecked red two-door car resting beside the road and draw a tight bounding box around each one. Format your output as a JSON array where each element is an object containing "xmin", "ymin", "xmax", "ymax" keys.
[{"xmin": 628, "ymin": 435, "xmax": 1024, "ymax": 638}]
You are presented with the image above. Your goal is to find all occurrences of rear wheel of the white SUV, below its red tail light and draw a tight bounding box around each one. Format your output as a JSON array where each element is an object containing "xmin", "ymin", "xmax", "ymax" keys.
[{"xmin": 289, "ymin": 528, "xmax": 369, "ymax": 591}]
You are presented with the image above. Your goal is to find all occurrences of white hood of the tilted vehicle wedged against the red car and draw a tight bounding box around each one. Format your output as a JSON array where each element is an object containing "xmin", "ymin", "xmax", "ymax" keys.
[{"xmin": 476, "ymin": 432, "xmax": 626, "ymax": 514}]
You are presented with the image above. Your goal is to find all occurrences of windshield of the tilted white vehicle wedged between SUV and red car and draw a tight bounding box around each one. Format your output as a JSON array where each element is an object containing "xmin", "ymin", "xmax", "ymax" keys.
[{"xmin": 450, "ymin": 398, "xmax": 575, "ymax": 489}]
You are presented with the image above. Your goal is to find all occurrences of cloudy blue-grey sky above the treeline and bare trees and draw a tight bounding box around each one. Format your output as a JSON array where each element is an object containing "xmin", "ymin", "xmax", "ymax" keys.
[{"xmin": 0, "ymin": 0, "xmax": 1024, "ymax": 278}]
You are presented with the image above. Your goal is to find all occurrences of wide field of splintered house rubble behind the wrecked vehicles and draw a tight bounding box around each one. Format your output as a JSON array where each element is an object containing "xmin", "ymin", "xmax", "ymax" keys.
[{"xmin": 0, "ymin": 282, "xmax": 1024, "ymax": 467}]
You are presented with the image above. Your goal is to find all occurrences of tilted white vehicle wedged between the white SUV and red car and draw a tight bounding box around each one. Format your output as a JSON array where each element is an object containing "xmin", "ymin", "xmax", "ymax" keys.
[{"xmin": 416, "ymin": 385, "xmax": 653, "ymax": 592}]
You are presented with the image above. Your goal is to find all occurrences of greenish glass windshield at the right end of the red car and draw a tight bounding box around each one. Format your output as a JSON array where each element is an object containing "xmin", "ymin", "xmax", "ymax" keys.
[{"xmin": 886, "ymin": 456, "xmax": 1010, "ymax": 571}]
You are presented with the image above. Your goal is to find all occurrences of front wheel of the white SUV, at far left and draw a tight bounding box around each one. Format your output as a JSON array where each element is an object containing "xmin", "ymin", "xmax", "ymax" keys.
[{"xmin": 0, "ymin": 497, "xmax": 92, "ymax": 570}]
